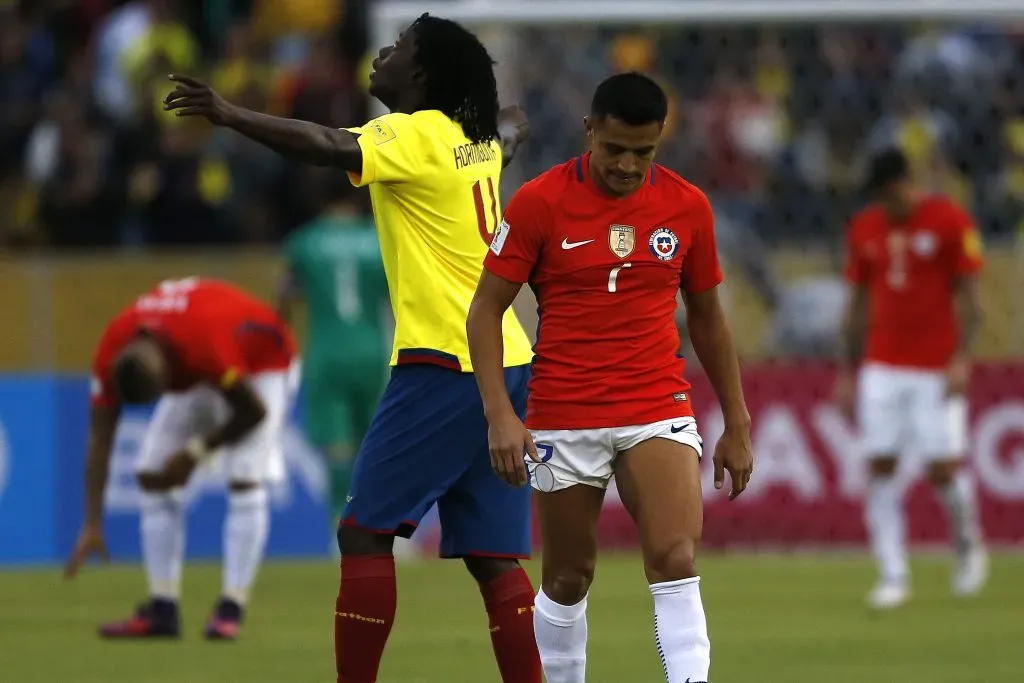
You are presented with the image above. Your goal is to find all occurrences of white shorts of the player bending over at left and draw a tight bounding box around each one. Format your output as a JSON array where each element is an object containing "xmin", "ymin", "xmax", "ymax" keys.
[{"xmin": 135, "ymin": 370, "xmax": 294, "ymax": 483}]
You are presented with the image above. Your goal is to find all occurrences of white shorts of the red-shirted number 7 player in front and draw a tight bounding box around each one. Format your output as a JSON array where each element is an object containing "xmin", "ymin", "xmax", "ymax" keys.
[{"xmin": 526, "ymin": 418, "xmax": 703, "ymax": 493}]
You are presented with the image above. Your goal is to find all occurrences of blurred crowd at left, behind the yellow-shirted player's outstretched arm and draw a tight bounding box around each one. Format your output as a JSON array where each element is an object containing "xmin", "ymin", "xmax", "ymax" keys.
[{"xmin": 0, "ymin": 0, "xmax": 368, "ymax": 248}]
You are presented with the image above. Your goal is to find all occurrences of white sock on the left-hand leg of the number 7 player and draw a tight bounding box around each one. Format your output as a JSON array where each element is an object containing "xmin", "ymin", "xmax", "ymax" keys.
[{"xmin": 534, "ymin": 589, "xmax": 587, "ymax": 683}]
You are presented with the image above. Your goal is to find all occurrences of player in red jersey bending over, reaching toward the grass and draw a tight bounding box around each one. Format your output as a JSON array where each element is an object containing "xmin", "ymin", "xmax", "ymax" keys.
[{"xmin": 66, "ymin": 278, "xmax": 295, "ymax": 640}]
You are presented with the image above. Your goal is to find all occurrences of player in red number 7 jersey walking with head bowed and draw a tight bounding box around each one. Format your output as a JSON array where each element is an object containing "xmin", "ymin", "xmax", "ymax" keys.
[{"xmin": 467, "ymin": 74, "xmax": 752, "ymax": 683}]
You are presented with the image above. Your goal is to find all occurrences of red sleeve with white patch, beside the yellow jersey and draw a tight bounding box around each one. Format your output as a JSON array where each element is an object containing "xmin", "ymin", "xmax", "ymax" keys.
[{"xmin": 483, "ymin": 185, "xmax": 549, "ymax": 283}]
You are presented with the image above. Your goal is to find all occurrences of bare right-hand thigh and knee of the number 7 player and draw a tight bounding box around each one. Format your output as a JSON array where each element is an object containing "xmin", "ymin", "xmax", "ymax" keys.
[{"xmin": 615, "ymin": 437, "xmax": 703, "ymax": 584}]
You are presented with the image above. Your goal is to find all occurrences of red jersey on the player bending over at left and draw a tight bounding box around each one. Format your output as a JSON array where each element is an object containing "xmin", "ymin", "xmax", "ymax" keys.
[{"xmin": 92, "ymin": 278, "xmax": 295, "ymax": 407}]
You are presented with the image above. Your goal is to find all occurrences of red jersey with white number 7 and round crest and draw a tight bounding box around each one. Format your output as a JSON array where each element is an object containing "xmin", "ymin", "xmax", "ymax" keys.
[{"xmin": 484, "ymin": 155, "xmax": 722, "ymax": 429}]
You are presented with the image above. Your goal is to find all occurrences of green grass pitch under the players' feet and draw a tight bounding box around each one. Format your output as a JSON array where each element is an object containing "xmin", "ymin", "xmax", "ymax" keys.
[{"xmin": 0, "ymin": 555, "xmax": 1024, "ymax": 683}]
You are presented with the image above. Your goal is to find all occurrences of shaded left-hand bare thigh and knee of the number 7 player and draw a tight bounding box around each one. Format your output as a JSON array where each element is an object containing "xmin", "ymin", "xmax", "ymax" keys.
[{"xmin": 534, "ymin": 483, "xmax": 605, "ymax": 605}]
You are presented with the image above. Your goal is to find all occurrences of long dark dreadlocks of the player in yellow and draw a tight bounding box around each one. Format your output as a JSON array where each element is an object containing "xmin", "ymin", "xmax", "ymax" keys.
[{"xmin": 413, "ymin": 14, "xmax": 499, "ymax": 142}]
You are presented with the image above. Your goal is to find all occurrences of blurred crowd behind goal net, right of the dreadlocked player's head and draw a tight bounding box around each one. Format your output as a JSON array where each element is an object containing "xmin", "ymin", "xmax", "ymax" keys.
[{"xmin": 516, "ymin": 23, "xmax": 1024, "ymax": 243}]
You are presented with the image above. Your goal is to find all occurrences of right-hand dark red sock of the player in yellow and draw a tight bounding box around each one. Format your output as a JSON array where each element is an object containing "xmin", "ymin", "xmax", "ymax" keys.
[{"xmin": 480, "ymin": 567, "xmax": 544, "ymax": 683}]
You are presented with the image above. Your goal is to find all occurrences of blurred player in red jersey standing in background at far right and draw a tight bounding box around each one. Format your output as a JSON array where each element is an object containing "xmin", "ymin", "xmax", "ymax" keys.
[{"xmin": 837, "ymin": 151, "xmax": 988, "ymax": 608}]
